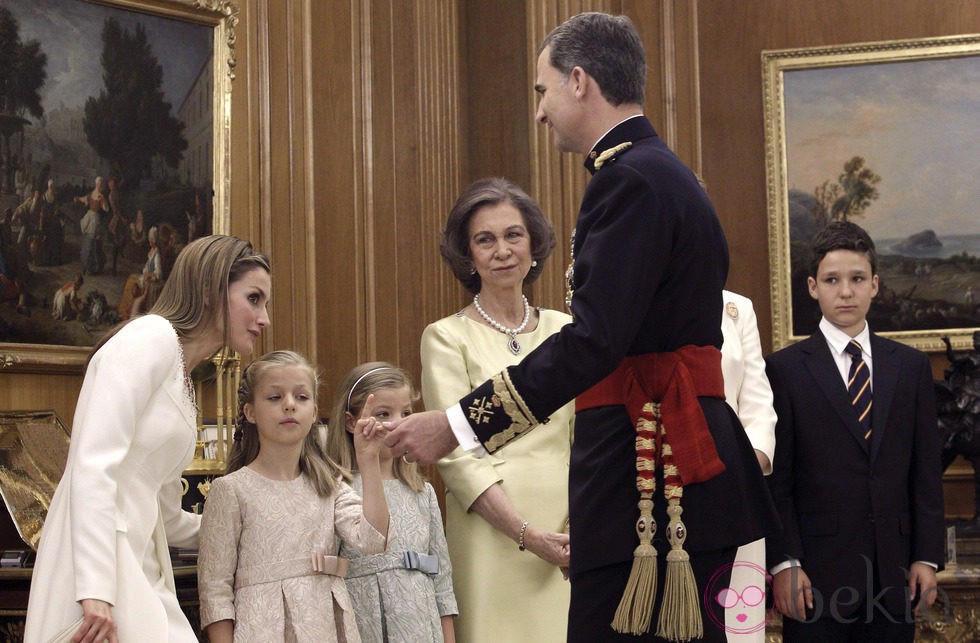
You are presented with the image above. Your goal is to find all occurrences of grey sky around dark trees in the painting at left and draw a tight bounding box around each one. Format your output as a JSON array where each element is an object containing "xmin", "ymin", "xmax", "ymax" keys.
[{"xmin": 3, "ymin": 0, "xmax": 213, "ymax": 113}]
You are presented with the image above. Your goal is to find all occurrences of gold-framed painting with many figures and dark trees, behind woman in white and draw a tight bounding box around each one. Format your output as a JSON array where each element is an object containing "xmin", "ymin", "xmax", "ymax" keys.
[{"xmin": 0, "ymin": 0, "xmax": 238, "ymax": 372}]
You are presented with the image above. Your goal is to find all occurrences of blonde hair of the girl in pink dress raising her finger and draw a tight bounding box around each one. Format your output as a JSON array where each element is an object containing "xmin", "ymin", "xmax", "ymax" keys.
[{"xmin": 226, "ymin": 351, "xmax": 350, "ymax": 497}]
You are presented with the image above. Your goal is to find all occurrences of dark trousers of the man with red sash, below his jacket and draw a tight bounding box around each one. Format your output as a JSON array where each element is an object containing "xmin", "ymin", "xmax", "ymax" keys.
[{"xmin": 568, "ymin": 548, "xmax": 735, "ymax": 643}]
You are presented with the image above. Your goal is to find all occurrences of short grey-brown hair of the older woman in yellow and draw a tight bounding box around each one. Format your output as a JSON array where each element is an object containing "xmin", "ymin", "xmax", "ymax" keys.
[{"xmin": 439, "ymin": 177, "xmax": 555, "ymax": 294}]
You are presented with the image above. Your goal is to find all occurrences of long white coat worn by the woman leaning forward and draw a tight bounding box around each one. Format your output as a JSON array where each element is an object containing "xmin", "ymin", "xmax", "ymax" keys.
[{"xmin": 24, "ymin": 315, "xmax": 200, "ymax": 643}]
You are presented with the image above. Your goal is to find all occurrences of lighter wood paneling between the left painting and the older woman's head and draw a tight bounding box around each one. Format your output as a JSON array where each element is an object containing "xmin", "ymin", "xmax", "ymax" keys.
[{"xmin": 233, "ymin": 0, "xmax": 465, "ymax": 402}]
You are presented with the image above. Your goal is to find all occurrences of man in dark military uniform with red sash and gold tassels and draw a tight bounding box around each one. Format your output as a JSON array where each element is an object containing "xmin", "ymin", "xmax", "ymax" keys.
[{"xmin": 386, "ymin": 13, "xmax": 777, "ymax": 642}]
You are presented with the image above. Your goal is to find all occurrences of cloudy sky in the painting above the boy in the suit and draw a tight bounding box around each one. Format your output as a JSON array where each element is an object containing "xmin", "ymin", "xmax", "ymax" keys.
[{"xmin": 783, "ymin": 56, "xmax": 980, "ymax": 239}]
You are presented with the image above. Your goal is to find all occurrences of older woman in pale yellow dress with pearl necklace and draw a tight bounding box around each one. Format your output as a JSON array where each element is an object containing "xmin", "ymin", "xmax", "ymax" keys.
[{"xmin": 421, "ymin": 178, "xmax": 574, "ymax": 643}]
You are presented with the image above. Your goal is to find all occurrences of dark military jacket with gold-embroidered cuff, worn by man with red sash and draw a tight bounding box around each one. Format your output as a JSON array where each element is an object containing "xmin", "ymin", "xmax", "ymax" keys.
[{"xmin": 460, "ymin": 117, "xmax": 775, "ymax": 576}]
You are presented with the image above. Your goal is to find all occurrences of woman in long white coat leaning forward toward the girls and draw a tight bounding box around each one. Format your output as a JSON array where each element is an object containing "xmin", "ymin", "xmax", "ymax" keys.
[{"xmin": 24, "ymin": 235, "xmax": 271, "ymax": 643}]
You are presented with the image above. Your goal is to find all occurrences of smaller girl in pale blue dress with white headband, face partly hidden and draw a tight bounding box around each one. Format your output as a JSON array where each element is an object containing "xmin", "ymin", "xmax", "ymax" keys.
[{"xmin": 327, "ymin": 362, "xmax": 458, "ymax": 643}]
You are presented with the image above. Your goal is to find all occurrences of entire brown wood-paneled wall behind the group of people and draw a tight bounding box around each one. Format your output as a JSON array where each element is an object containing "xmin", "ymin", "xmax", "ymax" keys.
[{"xmin": 0, "ymin": 0, "xmax": 980, "ymax": 516}]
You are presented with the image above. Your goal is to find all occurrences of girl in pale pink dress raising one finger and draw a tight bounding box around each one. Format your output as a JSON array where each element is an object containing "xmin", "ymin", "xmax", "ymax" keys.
[{"xmin": 198, "ymin": 351, "xmax": 393, "ymax": 643}]
